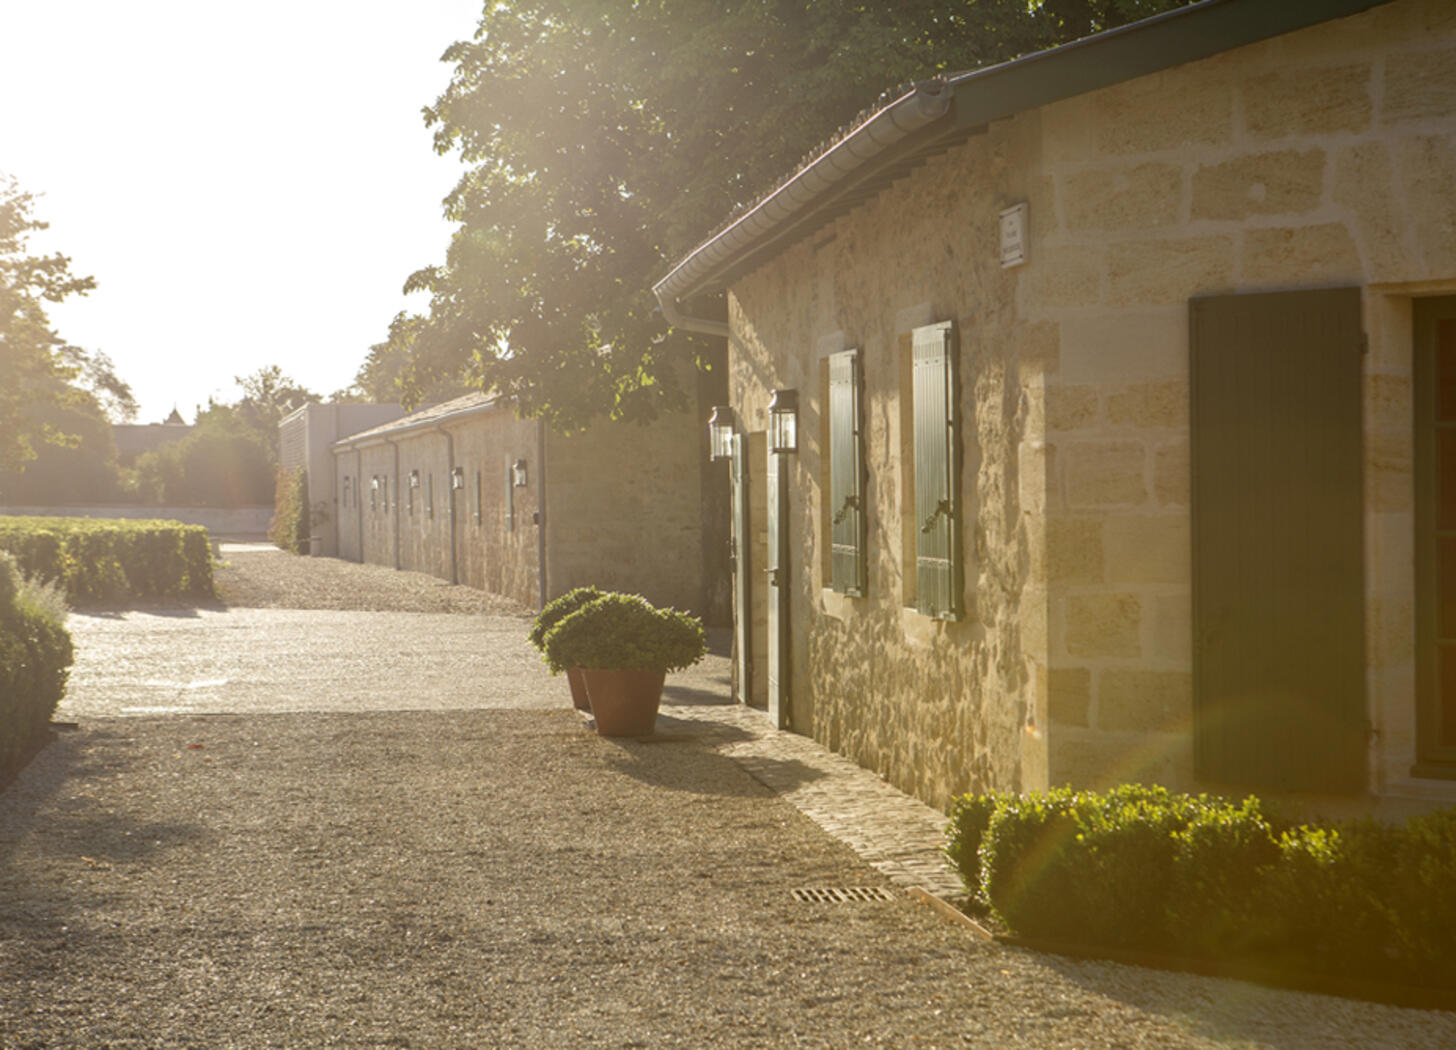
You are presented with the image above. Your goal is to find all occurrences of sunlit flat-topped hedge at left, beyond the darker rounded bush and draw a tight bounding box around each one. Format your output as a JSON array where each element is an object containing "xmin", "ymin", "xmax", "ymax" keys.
[{"xmin": 0, "ymin": 517, "xmax": 214, "ymax": 604}]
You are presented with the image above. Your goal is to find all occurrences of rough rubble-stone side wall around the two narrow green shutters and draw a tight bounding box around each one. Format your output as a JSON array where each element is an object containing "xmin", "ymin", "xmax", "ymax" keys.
[{"xmin": 729, "ymin": 112, "xmax": 1056, "ymax": 805}]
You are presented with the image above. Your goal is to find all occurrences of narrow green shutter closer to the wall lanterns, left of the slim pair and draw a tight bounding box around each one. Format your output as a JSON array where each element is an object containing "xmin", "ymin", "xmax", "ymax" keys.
[{"xmin": 828, "ymin": 350, "xmax": 866, "ymax": 597}]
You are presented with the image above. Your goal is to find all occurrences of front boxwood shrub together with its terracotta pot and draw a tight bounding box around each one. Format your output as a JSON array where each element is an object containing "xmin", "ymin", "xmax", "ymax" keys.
[{"xmin": 545, "ymin": 594, "xmax": 708, "ymax": 737}]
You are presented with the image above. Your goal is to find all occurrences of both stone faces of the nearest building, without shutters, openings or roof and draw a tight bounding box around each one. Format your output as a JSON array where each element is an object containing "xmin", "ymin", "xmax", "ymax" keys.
[{"xmin": 729, "ymin": 0, "xmax": 1456, "ymax": 804}]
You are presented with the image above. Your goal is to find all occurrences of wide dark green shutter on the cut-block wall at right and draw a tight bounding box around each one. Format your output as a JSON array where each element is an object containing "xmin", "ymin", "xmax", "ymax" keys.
[{"xmin": 1190, "ymin": 288, "xmax": 1366, "ymax": 791}]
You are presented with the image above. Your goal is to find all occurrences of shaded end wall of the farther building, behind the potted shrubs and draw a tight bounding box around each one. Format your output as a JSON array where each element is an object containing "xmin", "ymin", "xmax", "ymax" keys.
[{"xmin": 546, "ymin": 411, "xmax": 708, "ymax": 615}]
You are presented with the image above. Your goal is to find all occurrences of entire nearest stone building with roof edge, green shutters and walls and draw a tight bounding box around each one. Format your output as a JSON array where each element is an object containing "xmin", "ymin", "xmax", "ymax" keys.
[{"xmin": 657, "ymin": 0, "xmax": 1456, "ymax": 811}]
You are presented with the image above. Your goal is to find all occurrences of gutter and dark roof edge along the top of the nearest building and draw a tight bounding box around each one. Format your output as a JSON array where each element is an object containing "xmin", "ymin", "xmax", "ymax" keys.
[{"xmin": 652, "ymin": 0, "xmax": 1390, "ymax": 316}]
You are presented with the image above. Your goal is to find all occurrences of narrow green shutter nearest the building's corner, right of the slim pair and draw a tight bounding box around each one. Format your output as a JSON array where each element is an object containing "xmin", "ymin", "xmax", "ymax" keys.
[{"xmin": 913, "ymin": 322, "xmax": 961, "ymax": 620}]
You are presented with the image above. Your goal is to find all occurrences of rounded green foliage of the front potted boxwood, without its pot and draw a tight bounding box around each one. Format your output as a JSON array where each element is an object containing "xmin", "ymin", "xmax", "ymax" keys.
[{"xmin": 545, "ymin": 594, "xmax": 708, "ymax": 674}]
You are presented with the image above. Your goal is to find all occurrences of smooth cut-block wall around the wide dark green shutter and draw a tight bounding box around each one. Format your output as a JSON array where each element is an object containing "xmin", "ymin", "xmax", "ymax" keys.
[{"xmin": 1036, "ymin": 0, "xmax": 1456, "ymax": 791}]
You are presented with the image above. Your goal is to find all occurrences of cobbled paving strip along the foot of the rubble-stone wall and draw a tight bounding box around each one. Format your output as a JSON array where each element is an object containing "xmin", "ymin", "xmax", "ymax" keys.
[{"xmin": 662, "ymin": 702, "xmax": 965, "ymax": 900}]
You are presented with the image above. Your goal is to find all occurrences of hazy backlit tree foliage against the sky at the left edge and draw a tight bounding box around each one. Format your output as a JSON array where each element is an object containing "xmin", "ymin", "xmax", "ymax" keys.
[{"xmin": 0, "ymin": 176, "xmax": 137, "ymax": 472}]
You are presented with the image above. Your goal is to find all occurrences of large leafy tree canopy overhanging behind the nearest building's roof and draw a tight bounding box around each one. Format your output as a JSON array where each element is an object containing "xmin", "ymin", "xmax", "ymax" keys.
[{"xmin": 369, "ymin": 0, "xmax": 1185, "ymax": 430}]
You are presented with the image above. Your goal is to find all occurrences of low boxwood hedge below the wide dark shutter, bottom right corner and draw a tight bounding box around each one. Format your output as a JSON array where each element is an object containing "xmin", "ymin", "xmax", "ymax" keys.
[{"xmin": 946, "ymin": 785, "xmax": 1456, "ymax": 989}]
